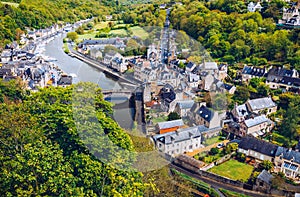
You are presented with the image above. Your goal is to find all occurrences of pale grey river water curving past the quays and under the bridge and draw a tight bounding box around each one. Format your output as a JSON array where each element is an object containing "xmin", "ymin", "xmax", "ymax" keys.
[{"xmin": 44, "ymin": 34, "xmax": 134, "ymax": 129}]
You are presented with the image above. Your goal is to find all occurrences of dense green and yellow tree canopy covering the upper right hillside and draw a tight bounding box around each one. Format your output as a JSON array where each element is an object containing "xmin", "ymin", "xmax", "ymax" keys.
[{"xmin": 170, "ymin": 0, "xmax": 300, "ymax": 67}]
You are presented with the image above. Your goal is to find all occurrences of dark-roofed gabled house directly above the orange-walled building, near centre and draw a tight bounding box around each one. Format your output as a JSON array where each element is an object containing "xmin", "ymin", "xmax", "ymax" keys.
[{"xmin": 159, "ymin": 84, "xmax": 176, "ymax": 112}]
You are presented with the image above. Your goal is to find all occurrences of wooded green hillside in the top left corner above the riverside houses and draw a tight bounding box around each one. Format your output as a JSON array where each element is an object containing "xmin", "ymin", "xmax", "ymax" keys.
[{"xmin": 0, "ymin": 0, "xmax": 111, "ymax": 47}]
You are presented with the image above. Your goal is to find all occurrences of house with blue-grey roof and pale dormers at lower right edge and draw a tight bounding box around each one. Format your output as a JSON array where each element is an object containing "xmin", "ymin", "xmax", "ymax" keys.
[{"xmin": 274, "ymin": 147, "xmax": 300, "ymax": 179}]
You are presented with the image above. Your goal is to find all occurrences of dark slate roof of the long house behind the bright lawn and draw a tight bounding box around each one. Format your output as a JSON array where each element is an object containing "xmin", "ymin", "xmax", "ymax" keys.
[{"xmin": 239, "ymin": 136, "xmax": 278, "ymax": 157}]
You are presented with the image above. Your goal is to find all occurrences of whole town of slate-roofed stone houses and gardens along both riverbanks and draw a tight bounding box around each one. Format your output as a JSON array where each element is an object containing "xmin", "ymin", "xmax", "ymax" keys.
[{"xmin": 0, "ymin": 1, "xmax": 300, "ymax": 196}]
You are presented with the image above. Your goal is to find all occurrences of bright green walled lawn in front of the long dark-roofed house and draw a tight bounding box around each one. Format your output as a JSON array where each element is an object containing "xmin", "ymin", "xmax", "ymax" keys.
[{"xmin": 209, "ymin": 160, "xmax": 254, "ymax": 182}]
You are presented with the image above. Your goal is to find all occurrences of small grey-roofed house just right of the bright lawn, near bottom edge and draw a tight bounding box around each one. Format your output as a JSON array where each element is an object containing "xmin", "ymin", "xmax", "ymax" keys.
[{"xmin": 253, "ymin": 170, "xmax": 274, "ymax": 194}]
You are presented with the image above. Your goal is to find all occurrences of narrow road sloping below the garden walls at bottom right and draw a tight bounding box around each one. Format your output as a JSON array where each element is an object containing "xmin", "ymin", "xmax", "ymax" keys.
[{"xmin": 170, "ymin": 164, "xmax": 272, "ymax": 197}]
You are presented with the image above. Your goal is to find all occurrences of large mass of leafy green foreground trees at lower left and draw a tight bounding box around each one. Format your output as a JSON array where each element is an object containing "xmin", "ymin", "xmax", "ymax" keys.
[{"xmin": 0, "ymin": 82, "xmax": 147, "ymax": 196}]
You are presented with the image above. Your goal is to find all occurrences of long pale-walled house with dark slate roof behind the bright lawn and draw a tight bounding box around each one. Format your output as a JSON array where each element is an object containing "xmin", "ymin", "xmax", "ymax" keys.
[{"xmin": 238, "ymin": 136, "xmax": 278, "ymax": 162}]
